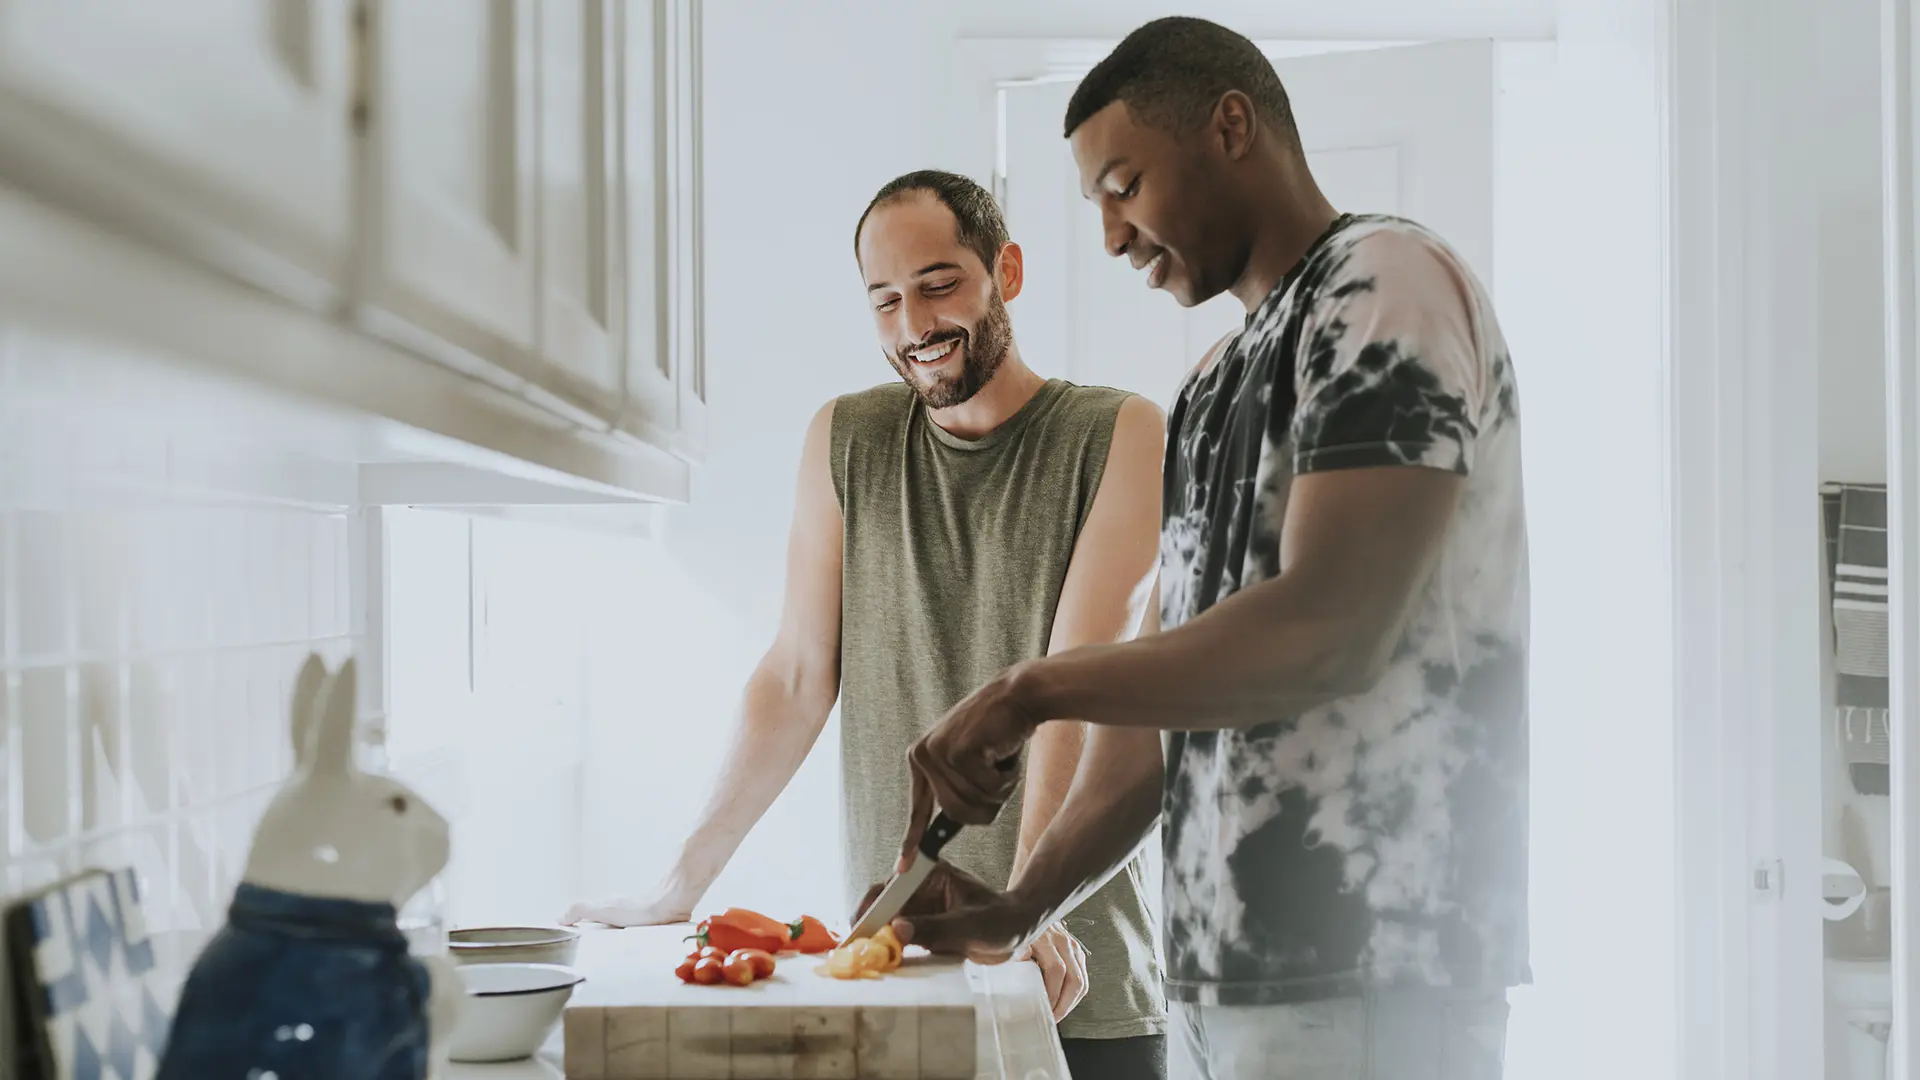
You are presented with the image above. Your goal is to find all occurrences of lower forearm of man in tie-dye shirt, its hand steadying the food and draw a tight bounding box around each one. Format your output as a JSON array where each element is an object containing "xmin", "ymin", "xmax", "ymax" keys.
[{"xmin": 1010, "ymin": 728, "xmax": 1164, "ymax": 930}]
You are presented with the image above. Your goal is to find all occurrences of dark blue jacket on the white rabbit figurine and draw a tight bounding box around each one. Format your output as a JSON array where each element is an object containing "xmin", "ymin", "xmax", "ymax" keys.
[{"xmin": 159, "ymin": 884, "xmax": 430, "ymax": 1080}]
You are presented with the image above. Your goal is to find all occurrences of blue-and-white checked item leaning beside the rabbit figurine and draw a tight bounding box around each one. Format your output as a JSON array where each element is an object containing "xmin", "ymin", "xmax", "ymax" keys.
[{"xmin": 10, "ymin": 871, "xmax": 169, "ymax": 1080}]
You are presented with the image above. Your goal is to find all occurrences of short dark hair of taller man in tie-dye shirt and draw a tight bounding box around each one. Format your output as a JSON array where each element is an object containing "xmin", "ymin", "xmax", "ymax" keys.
[{"xmin": 1066, "ymin": 15, "xmax": 1300, "ymax": 146}]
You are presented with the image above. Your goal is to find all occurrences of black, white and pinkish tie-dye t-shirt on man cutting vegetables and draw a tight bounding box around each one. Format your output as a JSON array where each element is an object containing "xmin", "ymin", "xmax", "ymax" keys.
[{"xmin": 1160, "ymin": 215, "xmax": 1530, "ymax": 1005}]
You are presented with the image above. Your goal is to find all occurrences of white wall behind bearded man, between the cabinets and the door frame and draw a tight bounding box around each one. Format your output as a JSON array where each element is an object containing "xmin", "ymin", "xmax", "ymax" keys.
[{"xmin": 637, "ymin": 0, "xmax": 956, "ymax": 919}]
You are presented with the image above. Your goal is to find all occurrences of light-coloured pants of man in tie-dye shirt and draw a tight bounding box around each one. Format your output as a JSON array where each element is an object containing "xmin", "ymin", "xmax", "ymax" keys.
[{"xmin": 1167, "ymin": 990, "xmax": 1507, "ymax": 1080}]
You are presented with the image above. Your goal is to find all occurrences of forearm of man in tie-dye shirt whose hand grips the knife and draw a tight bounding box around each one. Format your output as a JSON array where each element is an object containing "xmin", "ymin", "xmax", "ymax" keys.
[{"xmin": 1012, "ymin": 577, "xmax": 1373, "ymax": 730}]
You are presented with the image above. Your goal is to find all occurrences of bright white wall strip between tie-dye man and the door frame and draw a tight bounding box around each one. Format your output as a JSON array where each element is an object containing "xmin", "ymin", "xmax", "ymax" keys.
[{"xmin": 1494, "ymin": 0, "xmax": 1674, "ymax": 1080}]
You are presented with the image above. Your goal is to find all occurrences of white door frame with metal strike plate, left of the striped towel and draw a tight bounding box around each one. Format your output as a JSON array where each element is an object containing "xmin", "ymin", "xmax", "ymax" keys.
[{"xmin": 1667, "ymin": 0, "xmax": 1826, "ymax": 1080}]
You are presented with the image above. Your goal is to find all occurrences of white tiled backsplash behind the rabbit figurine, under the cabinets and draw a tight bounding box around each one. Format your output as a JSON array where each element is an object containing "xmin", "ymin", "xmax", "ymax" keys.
[{"xmin": 0, "ymin": 331, "xmax": 365, "ymax": 928}]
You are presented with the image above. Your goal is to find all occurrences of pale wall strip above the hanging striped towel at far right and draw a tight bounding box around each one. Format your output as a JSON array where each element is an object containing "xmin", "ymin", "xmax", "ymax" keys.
[{"xmin": 1814, "ymin": 0, "xmax": 1887, "ymax": 484}]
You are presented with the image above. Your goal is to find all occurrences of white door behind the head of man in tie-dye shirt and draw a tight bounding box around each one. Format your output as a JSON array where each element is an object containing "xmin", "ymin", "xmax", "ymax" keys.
[{"xmin": 1002, "ymin": 40, "xmax": 1496, "ymax": 405}]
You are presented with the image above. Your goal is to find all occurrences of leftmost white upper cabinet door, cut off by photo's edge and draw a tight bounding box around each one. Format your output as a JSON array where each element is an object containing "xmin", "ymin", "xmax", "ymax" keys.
[{"xmin": 0, "ymin": 0, "xmax": 353, "ymax": 304}]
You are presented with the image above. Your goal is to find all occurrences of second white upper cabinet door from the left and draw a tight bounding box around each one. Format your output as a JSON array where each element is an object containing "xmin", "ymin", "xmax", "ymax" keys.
[{"xmin": 363, "ymin": 0, "xmax": 540, "ymax": 375}]
